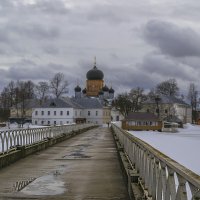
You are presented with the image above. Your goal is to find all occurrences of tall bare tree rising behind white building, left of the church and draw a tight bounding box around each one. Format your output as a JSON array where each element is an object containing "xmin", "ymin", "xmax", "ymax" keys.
[{"xmin": 50, "ymin": 73, "xmax": 68, "ymax": 98}]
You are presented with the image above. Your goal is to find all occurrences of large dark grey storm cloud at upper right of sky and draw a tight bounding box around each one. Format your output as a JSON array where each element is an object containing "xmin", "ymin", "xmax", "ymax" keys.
[{"xmin": 144, "ymin": 20, "xmax": 200, "ymax": 57}]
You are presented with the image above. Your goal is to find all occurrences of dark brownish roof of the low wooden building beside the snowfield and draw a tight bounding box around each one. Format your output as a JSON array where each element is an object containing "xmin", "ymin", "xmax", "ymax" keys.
[{"xmin": 125, "ymin": 112, "xmax": 159, "ymax": 121}]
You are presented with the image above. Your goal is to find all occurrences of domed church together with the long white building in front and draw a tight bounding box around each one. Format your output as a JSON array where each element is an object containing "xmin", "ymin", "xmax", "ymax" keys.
[{"xmin": 32, "ymin": 60, "xmax": 115, "ymax": 125}]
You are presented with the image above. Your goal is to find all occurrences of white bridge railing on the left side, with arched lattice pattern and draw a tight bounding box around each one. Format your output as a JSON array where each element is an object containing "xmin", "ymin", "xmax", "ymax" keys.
[{"xmin": 0, "ymin": 124, "xmax": 93, "ymax": 154}]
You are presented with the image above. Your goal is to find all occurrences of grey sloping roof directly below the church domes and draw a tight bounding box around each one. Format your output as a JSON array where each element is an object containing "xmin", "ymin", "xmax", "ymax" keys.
[{"xmin": 72, "ymin": 97, "xmax": 103, "ymax": 109}]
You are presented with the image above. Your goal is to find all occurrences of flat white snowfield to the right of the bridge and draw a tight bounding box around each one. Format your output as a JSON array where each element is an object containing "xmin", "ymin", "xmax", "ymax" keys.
[{"xmin": 129, "ymin": 124, "xmax": 200, "ymax": 175}]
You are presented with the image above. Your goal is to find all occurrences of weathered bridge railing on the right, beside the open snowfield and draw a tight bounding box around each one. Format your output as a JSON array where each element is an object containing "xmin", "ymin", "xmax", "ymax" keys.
[{"xmin": 112, "ymin": 124, "xmax": 200, "ymax": 200}]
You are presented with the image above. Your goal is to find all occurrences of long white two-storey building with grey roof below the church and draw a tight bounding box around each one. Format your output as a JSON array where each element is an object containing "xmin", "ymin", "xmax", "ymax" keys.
[{"xmin": 32, "ymin": 97, "xmax": 111, "ymax": 125}]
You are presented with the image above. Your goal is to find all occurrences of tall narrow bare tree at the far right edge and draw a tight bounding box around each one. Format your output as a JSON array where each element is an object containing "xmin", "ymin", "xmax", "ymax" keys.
[{"xmin": 187, "ymin": 83, "xmax": 198, "ymax": 122}]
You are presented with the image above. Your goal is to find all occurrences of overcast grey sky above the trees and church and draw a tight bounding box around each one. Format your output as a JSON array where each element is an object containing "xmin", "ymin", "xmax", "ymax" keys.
[{"xmin": 0, "ymin": 0, "xmax": 200, "ymax": 97}]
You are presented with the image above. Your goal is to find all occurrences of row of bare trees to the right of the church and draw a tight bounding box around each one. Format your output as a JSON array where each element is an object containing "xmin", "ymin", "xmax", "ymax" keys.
[{"xmin": 113, "ymin": 79, "xmax": 200, "ymax": 121}]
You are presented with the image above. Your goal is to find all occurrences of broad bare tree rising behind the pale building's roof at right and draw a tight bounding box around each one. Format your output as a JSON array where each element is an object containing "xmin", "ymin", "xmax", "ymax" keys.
[{"xmin": 156, "ymin": 79, "xmax": 179, "ymax": 96}]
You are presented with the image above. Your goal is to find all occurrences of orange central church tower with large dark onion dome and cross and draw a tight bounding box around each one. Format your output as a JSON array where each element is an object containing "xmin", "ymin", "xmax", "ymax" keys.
[{"xmin": 86, "ymin": 58, "xmax": 104, "ymax": 97}]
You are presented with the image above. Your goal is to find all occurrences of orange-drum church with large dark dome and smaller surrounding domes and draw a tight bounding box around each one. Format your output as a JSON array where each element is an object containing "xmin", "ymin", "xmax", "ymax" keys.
[{"xmin": 74, "ymin": 59, "xmax": 115, "ymax": 99}]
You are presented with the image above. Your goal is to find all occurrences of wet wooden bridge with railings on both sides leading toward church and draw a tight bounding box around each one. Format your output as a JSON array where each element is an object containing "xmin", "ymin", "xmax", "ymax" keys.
[{"xmin": 0, "ymin": 124, "xmax": 200, "ymax": 200}]
